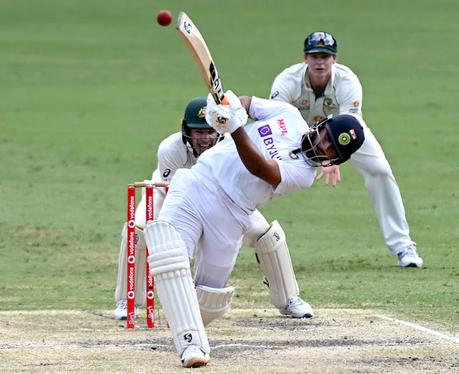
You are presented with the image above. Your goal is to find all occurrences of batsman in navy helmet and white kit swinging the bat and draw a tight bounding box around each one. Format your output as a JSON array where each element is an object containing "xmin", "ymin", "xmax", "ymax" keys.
[{"xmin": 144, "ymin": 91, "xmax": 364, "ymax": 368}]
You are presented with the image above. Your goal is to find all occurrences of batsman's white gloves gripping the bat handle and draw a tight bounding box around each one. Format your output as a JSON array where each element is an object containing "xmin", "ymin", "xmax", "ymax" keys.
[{"xmin": 206, "ymin": 91, "xmax": 248, "ymax": 134}]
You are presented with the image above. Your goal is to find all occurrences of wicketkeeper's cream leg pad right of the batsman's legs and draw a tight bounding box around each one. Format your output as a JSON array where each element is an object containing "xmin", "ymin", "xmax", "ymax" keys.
[{"xmin": 255, "ymin": 221, "xmax": 299, "ymax": 308}]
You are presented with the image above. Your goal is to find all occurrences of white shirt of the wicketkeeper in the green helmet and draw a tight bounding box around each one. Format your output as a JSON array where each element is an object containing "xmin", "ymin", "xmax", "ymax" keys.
[{"xmin": 152, "ymin": 132, "xmax": 196, "ymax": 182}]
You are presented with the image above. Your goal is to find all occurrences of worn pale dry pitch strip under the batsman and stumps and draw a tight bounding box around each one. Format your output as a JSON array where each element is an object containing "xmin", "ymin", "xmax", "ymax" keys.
[{"xmin": 0, "ymin": 309, "xmax": 459, "ymax": 374}]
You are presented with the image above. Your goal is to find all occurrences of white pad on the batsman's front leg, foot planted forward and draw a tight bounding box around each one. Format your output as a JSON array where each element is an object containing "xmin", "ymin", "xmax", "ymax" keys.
[{"xmin": 144, "ymin": 221, "xmax": 210, "ymax": 355}]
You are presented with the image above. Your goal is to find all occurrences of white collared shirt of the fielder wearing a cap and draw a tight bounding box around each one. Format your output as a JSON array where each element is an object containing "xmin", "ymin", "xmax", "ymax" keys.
[{"xmin": 269, "ymin": 62, "xmax": 362, "ymax": 125}]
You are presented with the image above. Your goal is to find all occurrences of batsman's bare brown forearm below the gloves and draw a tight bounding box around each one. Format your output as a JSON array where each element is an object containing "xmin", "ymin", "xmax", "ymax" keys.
[{"xmin": 231, "ymin": 127, "xmax": 281, "ymax": 188}]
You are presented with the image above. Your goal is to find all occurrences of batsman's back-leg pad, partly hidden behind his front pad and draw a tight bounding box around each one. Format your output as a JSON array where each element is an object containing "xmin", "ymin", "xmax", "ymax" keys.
[{"xmin": 196, "ymin": 286, "xmax": 234, "ymax": 326}]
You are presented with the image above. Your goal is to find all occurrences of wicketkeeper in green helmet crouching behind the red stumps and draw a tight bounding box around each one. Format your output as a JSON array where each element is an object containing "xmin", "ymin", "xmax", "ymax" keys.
[{"xmin": 114, "ymin": 97, "xmax": 313, "ymax": 318}]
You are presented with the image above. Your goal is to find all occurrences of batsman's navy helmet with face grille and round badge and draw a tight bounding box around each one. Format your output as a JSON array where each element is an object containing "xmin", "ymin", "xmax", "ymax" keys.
[{"xmin": 294, "ymin": 114, "xmax": 365, "ymax": 167}]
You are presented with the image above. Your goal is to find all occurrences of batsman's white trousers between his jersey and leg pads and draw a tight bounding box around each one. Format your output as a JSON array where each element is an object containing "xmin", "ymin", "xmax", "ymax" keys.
[{"xmin": 158, "ymin": 168, "xmax": 250, "ymax": 288}]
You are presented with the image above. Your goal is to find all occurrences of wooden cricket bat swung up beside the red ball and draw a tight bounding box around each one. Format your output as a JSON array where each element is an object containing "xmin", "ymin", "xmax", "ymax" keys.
[{"xmin": 177, "ymin": 12, "xmax": 228, "ymax": 104}]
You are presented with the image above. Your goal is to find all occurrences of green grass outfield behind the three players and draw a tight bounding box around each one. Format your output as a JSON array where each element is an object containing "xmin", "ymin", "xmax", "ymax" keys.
[{"xmin": 0, "ymin": 0, "xmax": 459, "ymax": 332}]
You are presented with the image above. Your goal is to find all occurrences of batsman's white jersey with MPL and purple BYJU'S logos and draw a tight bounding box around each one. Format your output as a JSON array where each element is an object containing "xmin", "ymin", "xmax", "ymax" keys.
[{"xmin": 192, "ymin": 97, "xmax": 315, "ymax": 214}]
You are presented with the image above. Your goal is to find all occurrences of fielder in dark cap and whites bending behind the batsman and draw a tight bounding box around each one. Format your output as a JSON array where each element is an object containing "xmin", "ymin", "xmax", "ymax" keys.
[{"xmin": 270, "ymin": 32, "xmax": 423, "ymax": 267}]
